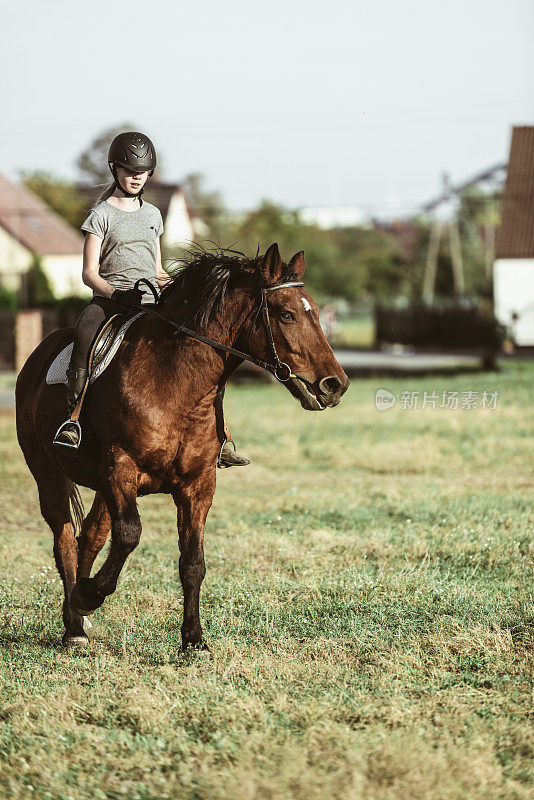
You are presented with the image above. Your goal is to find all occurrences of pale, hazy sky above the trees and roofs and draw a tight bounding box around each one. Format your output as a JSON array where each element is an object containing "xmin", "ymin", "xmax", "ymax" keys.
[{"xmin": 0, "ymin": 0, "xmax": 534, "ymax": 217}]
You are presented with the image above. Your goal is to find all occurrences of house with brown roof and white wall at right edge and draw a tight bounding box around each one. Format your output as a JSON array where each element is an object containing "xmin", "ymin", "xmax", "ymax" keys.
[{"xmin": 493, "ymin": 125, "xmax": 534, "ymax": 347}]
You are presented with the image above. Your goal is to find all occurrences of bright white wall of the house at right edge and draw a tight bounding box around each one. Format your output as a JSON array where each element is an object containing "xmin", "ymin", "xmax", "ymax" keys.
[{"xmin": 493, "ymin": 258, "xmax": 534, "ymax": 346}]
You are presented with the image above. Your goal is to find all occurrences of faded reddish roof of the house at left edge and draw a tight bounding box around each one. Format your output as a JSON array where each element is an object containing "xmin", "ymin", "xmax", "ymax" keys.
[{"xmin": 0, "ymin": 173, "xmax": 83, "ymax": 256}]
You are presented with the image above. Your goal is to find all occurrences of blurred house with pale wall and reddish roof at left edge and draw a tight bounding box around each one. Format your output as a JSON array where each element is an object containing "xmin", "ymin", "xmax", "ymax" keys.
[{"xmin": 0, "ymin": 173, "xmax": 87, "ymax": 297}]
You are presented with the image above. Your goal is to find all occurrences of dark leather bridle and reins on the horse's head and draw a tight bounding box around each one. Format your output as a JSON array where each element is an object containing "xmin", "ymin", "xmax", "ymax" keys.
[{"xmin": 135, "ymin": 273, "xmax": 304, "ymax": 383}]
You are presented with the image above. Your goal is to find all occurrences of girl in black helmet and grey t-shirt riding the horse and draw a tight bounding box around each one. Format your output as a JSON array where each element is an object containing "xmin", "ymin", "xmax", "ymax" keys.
[{"xmin": 54, "ymin": 131, "xmax": 250, "ymax": 466}]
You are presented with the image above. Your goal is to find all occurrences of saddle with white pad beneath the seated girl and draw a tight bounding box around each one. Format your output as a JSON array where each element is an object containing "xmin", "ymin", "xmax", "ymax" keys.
[{"xmin": 46, "ymin": 309, "xmax": 144, "ymax": 384}]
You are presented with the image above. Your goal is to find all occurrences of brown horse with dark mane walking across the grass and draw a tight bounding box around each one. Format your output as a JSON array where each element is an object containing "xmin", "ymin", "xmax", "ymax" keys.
[{"xmin": 16, "ymin": 244, "xmax": 349, "ymax": 649}]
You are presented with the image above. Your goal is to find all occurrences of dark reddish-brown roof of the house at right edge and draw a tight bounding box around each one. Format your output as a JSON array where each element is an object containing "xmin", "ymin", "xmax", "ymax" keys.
[{"xmin": 495, "ymin": 125, "xmax": 534, "ymax": 258}]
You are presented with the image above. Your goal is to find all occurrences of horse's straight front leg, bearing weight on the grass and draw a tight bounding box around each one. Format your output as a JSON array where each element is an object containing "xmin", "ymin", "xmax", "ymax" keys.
[{"xmin": 173, "ymin": 468, "xmax": 216, "ymax": 650}]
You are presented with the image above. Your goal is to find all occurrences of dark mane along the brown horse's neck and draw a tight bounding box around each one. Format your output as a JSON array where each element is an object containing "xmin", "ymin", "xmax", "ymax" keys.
[{"xmin": 158, "ymin": 244, "xmax": 300, "ymax": 326}]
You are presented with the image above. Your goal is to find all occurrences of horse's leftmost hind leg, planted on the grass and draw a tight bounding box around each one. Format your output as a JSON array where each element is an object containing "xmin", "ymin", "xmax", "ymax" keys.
[{"xmin": 32, "ymin": 462, "xmax": 89, "ymax": 646}]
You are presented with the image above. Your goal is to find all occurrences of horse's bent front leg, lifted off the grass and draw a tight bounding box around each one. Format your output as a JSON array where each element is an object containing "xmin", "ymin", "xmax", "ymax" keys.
[{"xmin": 71, "ymin": 451, "xmax": 141, "ymax": 615}]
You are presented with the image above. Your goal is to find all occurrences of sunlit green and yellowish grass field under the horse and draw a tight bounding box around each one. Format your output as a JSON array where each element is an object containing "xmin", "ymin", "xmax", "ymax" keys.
[{"xmin": 0, "ymin": 362, "xmax": 534, "ymax": 800}]
